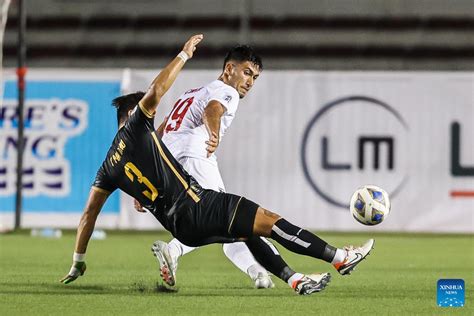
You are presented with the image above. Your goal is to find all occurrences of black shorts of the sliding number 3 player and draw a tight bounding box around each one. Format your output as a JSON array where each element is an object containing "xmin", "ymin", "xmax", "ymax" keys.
[{"xmin": 161, "ymin": 190, "xmax": 258, "ymax": 247}]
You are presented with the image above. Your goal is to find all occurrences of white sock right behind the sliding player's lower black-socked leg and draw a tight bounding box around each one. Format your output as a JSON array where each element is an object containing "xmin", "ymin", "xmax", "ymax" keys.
[{"xmin": 222, "ymin": 242, "xmax": 267, "ymax": 280}]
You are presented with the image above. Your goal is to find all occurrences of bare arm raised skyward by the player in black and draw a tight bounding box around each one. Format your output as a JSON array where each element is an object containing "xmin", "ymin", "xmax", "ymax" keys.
[{"xmin": 140, "ymin": 34, "xmax": 203, "ymax": 114}]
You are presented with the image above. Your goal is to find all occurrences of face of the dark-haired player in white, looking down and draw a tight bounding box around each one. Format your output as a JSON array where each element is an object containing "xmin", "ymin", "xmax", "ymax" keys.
[{"xmin": 226, "ymin": 61, "xmax": 260, "ymax": 99}]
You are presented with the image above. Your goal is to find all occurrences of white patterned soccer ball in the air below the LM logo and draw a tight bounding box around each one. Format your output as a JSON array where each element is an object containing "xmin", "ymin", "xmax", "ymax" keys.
[{"xmin": 350, "ymin": 185, "xmax": 390, "ymax": 225}]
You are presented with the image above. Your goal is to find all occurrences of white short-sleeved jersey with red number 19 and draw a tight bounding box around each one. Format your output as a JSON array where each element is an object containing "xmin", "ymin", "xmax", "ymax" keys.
[{"xmin": 162, "ymin": 80, "xmax": 239, "ymax": 165}]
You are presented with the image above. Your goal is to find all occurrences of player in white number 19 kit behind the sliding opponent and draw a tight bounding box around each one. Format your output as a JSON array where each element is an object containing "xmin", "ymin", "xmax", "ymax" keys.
[{"xmin": 152, "ymin": 45, "xmax": 277, "ymax": 288}]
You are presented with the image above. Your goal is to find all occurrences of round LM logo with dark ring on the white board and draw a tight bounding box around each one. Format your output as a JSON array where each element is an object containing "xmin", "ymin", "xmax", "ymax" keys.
[{"xmin": 301, "ymin": 95, "xmax": 410, "ymax": 210}]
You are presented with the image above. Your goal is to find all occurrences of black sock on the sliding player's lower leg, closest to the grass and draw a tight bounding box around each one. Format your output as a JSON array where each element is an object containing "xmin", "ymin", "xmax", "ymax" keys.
[{"xmin": 245, "ymin": 236, "xmax": 295, "ymax": 282}]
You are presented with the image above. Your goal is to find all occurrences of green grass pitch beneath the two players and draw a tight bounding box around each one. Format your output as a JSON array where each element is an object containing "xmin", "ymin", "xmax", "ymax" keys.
[{"xmin": 0, "ymin": 232, "xmax": 474, "ymax": 316}]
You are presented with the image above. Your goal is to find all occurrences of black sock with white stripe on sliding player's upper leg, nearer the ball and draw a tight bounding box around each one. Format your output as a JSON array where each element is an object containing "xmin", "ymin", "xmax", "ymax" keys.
[{"xmin": 272, "ymin": 218, "xmax": 336, "ymax": 262}]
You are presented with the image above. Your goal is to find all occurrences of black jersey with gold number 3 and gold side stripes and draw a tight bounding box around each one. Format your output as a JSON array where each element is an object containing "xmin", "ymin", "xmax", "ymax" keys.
[{"xmin": 93, "ymin": 105, "xmax": 203, "ymax": 231}]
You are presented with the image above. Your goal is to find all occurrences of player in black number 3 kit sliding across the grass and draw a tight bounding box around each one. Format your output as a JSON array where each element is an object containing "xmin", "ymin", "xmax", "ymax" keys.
[{"xmin": 61, "ymin": 35, "xmax": 374, "ymax": 294}]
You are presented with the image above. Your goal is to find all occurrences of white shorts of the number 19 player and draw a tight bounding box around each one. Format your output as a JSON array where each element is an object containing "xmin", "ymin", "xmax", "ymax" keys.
[{"xmin": 178, "ymin": 157, "xmax": 225, "ymax": 192}]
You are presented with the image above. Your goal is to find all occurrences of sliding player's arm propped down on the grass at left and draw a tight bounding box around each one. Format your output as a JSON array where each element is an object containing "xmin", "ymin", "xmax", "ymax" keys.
[{"xmin": 61, "ymin": 189, "xmax": 109, "ymax": 284}]
